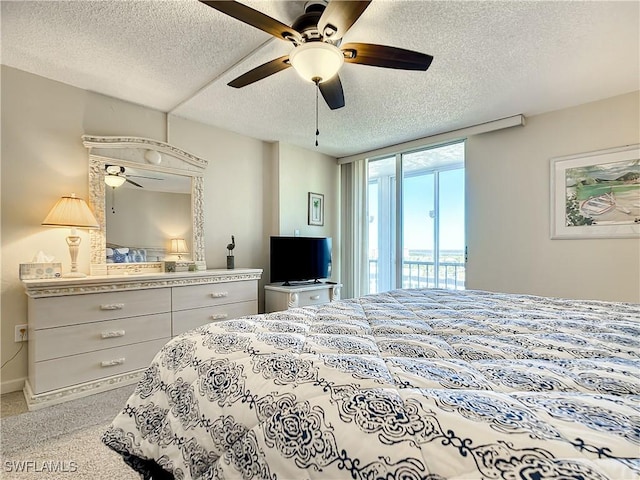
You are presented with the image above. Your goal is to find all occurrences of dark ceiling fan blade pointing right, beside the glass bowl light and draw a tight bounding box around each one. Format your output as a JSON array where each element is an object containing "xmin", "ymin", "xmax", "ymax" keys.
[{"xmin": 340, "ymin": 43, "xmax": 433, "ymax": 71}]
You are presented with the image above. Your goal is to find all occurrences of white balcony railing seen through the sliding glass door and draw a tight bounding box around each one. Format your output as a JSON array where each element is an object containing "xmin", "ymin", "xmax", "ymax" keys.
[{"xmin": 369, "ymin": 258, "xmax": 465, "ymax": 293}]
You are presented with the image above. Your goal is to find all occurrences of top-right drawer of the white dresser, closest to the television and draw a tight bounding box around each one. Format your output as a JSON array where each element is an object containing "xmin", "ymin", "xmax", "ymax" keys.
[{"xmin": 171, "ymin": 280, "xmax": 258, "ymax": 312}]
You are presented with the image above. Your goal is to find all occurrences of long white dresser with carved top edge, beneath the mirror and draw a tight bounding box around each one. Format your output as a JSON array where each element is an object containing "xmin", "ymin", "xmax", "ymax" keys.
[{"xmin": 23, "ymin": 269, "xmax": 262, "ymax": 410}]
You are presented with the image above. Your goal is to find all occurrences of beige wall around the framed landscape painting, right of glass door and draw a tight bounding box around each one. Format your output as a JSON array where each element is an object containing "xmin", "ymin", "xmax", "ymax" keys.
[{"xmin": 466, "ymin": 92, "xmax": 640, "ymax": 302}]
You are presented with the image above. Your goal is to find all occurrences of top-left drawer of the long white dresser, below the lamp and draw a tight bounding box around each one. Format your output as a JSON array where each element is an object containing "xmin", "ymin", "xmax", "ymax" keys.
[{"xmin": 29, "ymin": 288, "xmax": 171, "ymax": 329}]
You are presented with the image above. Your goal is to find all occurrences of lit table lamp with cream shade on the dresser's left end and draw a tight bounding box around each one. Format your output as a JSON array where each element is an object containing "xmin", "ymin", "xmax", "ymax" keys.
[{"xmin": 42, "ymin": 193, "xmax": 100, "ymax": 278}]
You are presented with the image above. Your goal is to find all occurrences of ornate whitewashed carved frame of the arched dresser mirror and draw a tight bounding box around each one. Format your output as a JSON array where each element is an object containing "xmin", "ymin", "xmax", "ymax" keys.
[{"xmin": 82, "ymin": 135, "xmax": 208, "ymax": 275}]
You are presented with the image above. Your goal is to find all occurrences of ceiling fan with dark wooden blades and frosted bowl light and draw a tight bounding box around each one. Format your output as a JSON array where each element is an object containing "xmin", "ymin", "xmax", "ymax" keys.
[{"xmin": 199, "ymin": 0, "xmax": 433, "ymax": 110}]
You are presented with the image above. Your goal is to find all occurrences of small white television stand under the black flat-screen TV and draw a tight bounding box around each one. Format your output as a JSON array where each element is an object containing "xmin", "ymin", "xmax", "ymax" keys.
[{"xmin": 264, "ymin": 282, "xmax": 342, "ymax": 313}]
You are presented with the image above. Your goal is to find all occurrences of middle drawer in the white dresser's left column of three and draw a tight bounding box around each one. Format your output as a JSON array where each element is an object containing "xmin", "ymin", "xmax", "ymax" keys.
[{"xmin": 29, "ymin": 312, "xmax": 171, "ymax": 362}]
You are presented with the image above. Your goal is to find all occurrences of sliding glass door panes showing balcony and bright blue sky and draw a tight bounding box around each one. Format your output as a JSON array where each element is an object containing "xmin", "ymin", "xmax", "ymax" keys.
[{"xmin": 367, "ymin": 142, "xmax": 465, "ymax": 293}]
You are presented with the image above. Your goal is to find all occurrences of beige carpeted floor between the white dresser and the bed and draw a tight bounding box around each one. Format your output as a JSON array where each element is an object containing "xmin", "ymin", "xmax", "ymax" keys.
[{"xmin": 0, "ymin": 385, "xmax": 140, "ymax": 480}]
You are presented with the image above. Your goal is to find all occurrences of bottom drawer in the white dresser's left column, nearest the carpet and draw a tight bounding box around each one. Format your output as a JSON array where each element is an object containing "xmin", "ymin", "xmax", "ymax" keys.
[{"xmin": 29, "ymin": 337, "xmax": 169, "ymax": 394}]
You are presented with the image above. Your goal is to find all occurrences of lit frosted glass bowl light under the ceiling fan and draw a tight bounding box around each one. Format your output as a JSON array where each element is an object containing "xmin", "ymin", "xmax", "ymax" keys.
[{"xmin": 289, "ymin": 42, "xmax": 344, "ymax": 83}]
